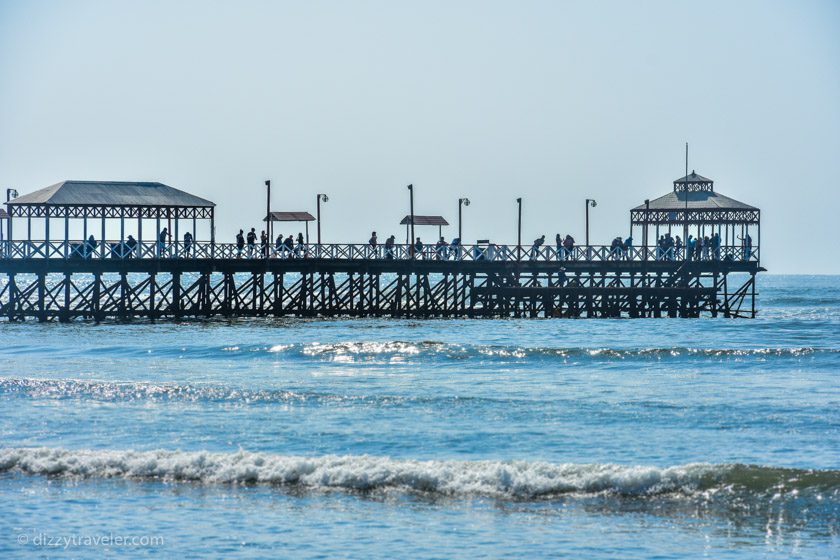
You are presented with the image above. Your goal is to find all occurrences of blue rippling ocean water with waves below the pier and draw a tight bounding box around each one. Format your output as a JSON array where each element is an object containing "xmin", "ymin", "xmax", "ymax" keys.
[{"xmin": 0, "ymin": 275, "xmax": 840, "ymax": 559}]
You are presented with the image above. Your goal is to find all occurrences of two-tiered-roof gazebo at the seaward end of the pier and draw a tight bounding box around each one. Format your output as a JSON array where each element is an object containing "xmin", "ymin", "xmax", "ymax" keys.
[{"xmin": 630, "ymin": 171, "xmax": 761, "ymax": 260}]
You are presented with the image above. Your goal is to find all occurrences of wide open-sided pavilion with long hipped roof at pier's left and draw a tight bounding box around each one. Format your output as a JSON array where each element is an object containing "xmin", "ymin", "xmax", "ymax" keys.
[{"xmin": 7, "ymin": 181, "xmax": 216, "ymax": 258}]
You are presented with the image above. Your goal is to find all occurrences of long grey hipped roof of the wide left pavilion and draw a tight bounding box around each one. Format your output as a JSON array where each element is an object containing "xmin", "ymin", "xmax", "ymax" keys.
[{"xmin": 9, "ymin": 181, "xmax": 216, "ymax": 208}]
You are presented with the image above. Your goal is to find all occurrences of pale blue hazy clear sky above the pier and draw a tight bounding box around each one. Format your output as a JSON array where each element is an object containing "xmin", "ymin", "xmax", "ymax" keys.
[{"xmin": 0, "ymin": 0, "xmax": 840, "ymax": 274}]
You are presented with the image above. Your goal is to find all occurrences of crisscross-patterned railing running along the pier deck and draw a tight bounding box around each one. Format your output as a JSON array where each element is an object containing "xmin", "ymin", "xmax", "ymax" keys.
[{"xmin": 0, "ymin": 240, "xmax": 759, "ymax": 262}]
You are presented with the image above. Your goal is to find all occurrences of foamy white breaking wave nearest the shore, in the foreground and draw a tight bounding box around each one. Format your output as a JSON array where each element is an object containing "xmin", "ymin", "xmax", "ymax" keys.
[{"xmin": 0, "ymin": 448, "xmax": 840, "ymax": 500}]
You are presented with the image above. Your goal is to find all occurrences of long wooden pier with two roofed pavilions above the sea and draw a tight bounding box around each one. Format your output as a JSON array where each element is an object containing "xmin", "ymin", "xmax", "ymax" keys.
[{"xmin": 0, "ymin": 173, "xmax": 764, "ymax": 321}]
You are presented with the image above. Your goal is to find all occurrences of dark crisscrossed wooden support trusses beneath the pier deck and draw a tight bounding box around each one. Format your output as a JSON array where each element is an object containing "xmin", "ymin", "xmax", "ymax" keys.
[{"xmin": 0, "ymin": 259, "xmax": 764, "ymax": 321}]
